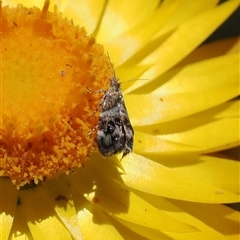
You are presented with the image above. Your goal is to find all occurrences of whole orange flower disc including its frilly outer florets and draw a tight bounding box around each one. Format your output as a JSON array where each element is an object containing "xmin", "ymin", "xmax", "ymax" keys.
[{"xmin": 0, "ymin": 1, "xmax": 112, "ymax": 187}]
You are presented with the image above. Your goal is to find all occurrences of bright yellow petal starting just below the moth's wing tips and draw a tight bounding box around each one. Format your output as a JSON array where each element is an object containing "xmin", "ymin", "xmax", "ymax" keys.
[{"xmin": 122, "ymin": 153, "xmax": 239, "ymax": 203}]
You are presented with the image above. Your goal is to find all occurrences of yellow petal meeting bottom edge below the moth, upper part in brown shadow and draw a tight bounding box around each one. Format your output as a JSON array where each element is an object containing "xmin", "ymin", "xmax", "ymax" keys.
[{"xmin": 61, "ymin": 166, "xmax": 126, "ymax": 239}]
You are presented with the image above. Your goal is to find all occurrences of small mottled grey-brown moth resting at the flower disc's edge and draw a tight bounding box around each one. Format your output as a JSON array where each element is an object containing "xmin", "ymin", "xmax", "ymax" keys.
[{"xmin": 96, "ymin": 74, "xmax": 134, "ymax": 158}]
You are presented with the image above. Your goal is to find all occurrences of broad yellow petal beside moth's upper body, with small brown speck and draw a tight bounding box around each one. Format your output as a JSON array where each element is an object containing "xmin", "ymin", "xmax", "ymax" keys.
[{"xmin": 125, "ymin": 54, "xmax": 239, "ymax": 126}]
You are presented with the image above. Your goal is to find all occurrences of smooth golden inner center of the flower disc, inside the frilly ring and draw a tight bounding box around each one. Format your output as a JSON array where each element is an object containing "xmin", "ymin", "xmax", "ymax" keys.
[{"xmin": 2, "ymin": 20, "xmax": 73, "ymax": 130}]
